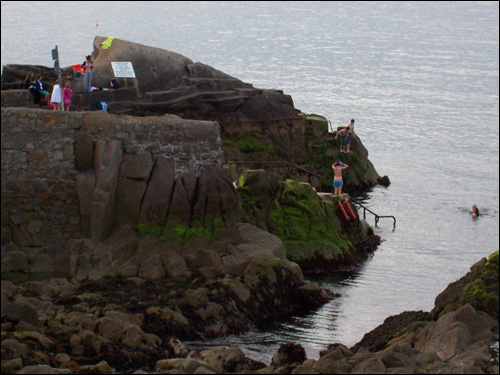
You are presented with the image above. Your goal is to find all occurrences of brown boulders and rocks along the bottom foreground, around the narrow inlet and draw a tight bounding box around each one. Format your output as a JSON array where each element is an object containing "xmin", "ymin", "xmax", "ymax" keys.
[{"xmin": 2, "ymin": 252, "xmax": 499, "ymax": 374}]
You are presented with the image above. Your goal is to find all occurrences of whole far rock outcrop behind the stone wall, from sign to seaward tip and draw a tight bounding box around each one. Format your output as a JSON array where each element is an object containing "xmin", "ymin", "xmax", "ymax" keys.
[{"xmin": 2, "ymin": 37, "xmax": 390, "ymax": 192}]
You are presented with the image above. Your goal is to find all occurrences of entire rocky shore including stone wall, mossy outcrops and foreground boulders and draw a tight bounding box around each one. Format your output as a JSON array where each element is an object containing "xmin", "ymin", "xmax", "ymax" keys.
[{"xmin": 1, "ymin": 37, "xmax": 498, "ymax": 374}]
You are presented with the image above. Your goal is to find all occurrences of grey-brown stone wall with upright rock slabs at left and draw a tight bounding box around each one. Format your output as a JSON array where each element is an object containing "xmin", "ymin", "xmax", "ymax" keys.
[{"xmin": 1, "ymin": 108, "xmax": 229, "ymax": 247}]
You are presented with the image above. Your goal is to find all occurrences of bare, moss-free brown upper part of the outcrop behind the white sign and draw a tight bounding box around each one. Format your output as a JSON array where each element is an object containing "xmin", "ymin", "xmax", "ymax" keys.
[{"xmin": 86, "ymin": 37, "xmax": 306, "ymax": 164}]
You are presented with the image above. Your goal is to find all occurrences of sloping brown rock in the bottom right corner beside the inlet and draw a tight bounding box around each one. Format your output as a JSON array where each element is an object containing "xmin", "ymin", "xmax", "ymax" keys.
[{"xmin": 252, "ymin": 251, "xmax": 499, "ymax": 374}]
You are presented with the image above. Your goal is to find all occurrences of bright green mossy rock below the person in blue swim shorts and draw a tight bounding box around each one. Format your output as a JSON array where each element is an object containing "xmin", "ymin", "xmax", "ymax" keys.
[{"xmin": 237, "ymin": 170, "xmax": 376, "ymax": 273}]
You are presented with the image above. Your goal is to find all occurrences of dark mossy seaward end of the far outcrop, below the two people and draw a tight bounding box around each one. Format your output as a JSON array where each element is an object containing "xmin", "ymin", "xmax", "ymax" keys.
[{"xmin": 222, "ymin": 114, "xmax": 390, "ymax": 193}]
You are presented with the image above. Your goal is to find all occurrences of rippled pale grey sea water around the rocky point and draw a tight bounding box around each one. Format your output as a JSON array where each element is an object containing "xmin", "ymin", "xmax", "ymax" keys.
[{"xmin": 1, "ymin": 1, "xmax": 499, "ymax": 362}]
